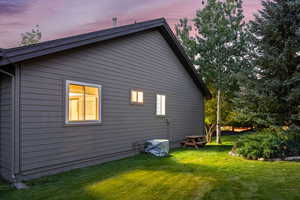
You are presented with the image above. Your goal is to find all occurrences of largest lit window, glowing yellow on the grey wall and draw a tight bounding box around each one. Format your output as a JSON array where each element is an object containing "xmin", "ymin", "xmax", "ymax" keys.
[{"xmin": 66, "ymin": 81, "xmax": 101, "ymax": 123}]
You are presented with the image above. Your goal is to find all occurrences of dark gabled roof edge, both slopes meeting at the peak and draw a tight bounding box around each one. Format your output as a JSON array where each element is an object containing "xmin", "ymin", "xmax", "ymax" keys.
[{"xmin": 0, "ymin": 18, "xmax": 211, "ymax": 99}]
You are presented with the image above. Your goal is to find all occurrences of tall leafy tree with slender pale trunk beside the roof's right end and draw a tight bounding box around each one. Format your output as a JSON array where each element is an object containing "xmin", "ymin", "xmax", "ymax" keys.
[{"xmin": 176, "ymin": 0, "xmax": 247, "ymax": 143}]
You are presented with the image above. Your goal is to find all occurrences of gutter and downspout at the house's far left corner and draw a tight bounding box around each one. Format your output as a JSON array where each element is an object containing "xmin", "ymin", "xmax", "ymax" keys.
[{"xmin": 0, "ymin": 49, "xmax": 17, "ymax": 183}]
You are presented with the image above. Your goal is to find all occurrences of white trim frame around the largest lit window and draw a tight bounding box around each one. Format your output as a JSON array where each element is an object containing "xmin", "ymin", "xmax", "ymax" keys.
[{"xmin": 65, "ymin": 80, "xmax": 102, "ymax": 125}]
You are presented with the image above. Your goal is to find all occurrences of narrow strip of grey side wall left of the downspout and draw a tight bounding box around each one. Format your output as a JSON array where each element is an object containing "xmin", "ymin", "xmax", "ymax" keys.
[{"xmin": 0, "ymin": 74, "xmax": 12, "ymax": 180}]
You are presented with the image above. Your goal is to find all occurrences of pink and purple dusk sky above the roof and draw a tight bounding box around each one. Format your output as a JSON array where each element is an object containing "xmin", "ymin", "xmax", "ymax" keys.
[{"xmin": 0, "ymin": 0, "xmax": 261, "ymax": 48}]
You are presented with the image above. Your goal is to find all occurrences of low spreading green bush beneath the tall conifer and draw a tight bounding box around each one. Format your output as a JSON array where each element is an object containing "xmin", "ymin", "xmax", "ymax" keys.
[{"xmin": 233, "ymin": 129, "xmax": 300, "ymax": 160}]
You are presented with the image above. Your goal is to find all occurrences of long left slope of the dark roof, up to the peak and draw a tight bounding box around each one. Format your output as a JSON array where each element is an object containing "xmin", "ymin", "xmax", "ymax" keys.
[{"xmin": 0, "ymin": 19, "xmax": 165, "ymax": 66}]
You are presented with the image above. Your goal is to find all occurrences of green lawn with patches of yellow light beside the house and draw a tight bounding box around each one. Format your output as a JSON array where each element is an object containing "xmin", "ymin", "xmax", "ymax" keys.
[{"xmin": 0, "ymin": 136, "xmax": 300, "ymax": 200}]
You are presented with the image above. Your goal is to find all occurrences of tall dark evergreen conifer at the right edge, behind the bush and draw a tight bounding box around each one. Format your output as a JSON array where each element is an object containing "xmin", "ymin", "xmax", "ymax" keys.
[{"xmin": 237, "ymin": 0, "xmax": 300, "ymax": 130}]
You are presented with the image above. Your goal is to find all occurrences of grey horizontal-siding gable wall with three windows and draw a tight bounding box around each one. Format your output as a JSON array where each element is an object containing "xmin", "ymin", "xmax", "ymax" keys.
[{"xmin": 16, "ymin": 31, "xmax": 204, "ymax": 179}]
